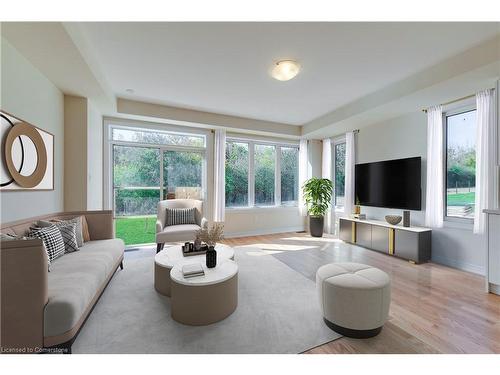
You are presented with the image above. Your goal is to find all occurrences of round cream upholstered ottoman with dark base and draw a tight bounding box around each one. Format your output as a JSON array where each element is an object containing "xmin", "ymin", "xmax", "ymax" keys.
[{"xmin": 316, "ymin": 263, "xmax": 391, "ymax": 338}]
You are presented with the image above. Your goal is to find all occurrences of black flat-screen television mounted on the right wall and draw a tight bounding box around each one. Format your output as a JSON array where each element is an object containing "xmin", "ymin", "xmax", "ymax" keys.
[{"xmin": 355, "ymin": 157, "xmax": 422, "ymax": 210}]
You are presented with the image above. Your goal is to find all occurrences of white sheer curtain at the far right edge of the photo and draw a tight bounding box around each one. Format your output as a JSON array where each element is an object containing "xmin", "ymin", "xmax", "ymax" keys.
[{"xmin": 474, "ymin": 89, "xmax": 497, "ymax": 234}]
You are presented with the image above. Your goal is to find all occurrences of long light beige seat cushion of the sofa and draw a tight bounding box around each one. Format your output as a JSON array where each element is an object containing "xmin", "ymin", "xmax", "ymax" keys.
[{"xmin": 44, "ymin": 239, "xmax": 125, "ymax": 337}]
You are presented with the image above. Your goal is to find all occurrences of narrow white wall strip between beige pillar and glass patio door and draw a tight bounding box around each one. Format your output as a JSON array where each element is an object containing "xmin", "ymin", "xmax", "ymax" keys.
[{"xmin": 87, "ymin": 100, "xmax": 103, "ymax": 210}]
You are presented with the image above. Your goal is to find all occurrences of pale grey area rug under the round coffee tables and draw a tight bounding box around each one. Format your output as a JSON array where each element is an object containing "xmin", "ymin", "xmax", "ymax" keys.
[{"xmin": 73, "ymin": 247, "xmax": 341, "ymax": 354}]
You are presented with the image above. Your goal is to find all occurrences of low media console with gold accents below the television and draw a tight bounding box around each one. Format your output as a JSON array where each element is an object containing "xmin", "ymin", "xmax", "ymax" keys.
[{"xmin": 339, "ymin": 218, "xmax": 432, "ymax": 263}]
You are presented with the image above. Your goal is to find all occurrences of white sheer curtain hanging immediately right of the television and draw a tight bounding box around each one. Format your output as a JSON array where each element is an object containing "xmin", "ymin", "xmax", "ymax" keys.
[{"xmin": 425, "ymin": 105, "xmax": 444, "ymax": 228}]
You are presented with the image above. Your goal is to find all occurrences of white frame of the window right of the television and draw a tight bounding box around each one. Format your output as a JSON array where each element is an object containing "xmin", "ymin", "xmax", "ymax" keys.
[{"xmin": 443, "ymin": 98, "xmax": 477, "ymax": 227}]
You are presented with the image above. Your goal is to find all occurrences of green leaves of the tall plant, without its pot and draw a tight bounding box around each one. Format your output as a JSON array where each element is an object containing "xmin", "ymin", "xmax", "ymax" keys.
[{"xmin": 302, "ymin": 177, "xmax": 333, "ymax": 217}]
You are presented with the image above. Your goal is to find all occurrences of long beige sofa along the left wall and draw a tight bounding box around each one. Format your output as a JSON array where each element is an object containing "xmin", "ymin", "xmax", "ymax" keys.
[{"xmin": 0, "ymin": 211, "xmax": 125, "ymax": 353}]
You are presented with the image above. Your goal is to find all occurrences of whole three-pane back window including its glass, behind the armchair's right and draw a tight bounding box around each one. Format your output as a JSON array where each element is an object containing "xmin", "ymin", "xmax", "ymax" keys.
[{"xmin": 226, "ymin": 139, "xmax": 299, "ymax": 208}]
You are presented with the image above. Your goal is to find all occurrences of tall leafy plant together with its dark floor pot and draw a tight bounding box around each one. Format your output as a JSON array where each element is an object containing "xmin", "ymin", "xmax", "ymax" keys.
[{"xmin": 302, "ymin": 177, "xmax": 333, "ymax": 237}]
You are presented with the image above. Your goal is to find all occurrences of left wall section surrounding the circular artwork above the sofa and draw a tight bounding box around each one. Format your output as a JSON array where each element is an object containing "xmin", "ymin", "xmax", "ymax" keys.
[{"xmin": 0, "ymin": 38, "xmax": 64, "ymax": 222}]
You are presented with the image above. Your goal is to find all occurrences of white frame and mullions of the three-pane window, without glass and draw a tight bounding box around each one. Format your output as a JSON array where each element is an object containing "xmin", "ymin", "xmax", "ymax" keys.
[{"xmin": 225, "ymin": 135, "xmax": 299, "ymax": 212}]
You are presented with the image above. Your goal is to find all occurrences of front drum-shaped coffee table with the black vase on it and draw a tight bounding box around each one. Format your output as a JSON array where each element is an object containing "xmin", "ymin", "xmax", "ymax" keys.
[{"xmin": 170, "ymin": 260, "xmax": 238, "ymax": 326}]
